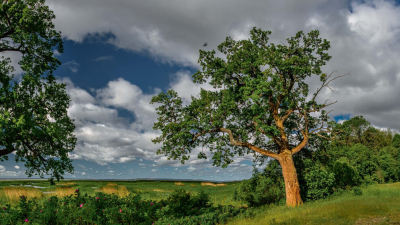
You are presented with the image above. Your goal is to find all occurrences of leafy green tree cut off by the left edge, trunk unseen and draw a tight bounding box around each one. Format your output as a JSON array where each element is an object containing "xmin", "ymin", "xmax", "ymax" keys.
[{"xmin": 0, "ymin": 0, "xmax": 76, "ymax": 184}]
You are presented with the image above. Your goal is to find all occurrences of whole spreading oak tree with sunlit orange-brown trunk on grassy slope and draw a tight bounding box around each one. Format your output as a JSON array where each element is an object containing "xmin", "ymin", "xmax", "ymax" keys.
[{"xmin": 150, "ymin": 27, "xmax": 350, "ymax": 206}]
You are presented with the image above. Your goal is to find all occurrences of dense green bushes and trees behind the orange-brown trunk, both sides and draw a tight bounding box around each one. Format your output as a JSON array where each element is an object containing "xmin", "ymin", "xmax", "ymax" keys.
[{"xmin": 235, "ymin": 116, "xmax": 400, "ymax": 207}]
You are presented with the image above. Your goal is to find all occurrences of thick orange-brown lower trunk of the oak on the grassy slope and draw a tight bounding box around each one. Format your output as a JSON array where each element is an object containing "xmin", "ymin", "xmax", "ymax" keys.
[{"xmin": 279, "ymin": 150, "xmax": 303, "ymax": 206}]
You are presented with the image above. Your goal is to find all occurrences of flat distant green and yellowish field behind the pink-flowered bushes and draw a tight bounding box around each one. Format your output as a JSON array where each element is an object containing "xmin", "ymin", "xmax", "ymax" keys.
[{"xmin": 0, "ymin": 180, "xmax": 246, "ymax": 209}]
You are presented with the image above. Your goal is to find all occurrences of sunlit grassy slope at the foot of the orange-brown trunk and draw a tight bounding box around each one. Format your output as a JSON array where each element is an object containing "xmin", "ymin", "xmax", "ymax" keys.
[{"xmin": 217, "ymin": 182, "xmax": 400, "ymax": 225}]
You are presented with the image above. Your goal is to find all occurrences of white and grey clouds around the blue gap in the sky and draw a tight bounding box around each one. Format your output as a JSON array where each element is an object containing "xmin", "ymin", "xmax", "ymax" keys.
[{"xmin": 0, "ymin": 0, "xmax": 400, "ymax": 180}]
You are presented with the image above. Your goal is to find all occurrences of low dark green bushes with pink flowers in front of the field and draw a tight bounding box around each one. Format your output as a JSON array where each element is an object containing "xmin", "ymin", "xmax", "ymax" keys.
[{"xmin": 0, "ymin": 186, "xmax": 260, "ymax": 225}]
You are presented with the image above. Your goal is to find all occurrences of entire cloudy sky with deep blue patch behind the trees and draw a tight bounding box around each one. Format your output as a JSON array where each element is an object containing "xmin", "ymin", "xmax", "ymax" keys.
[{"xmin": 0, "ymin": 0, "xmax": 400, "ymax": 181}]
